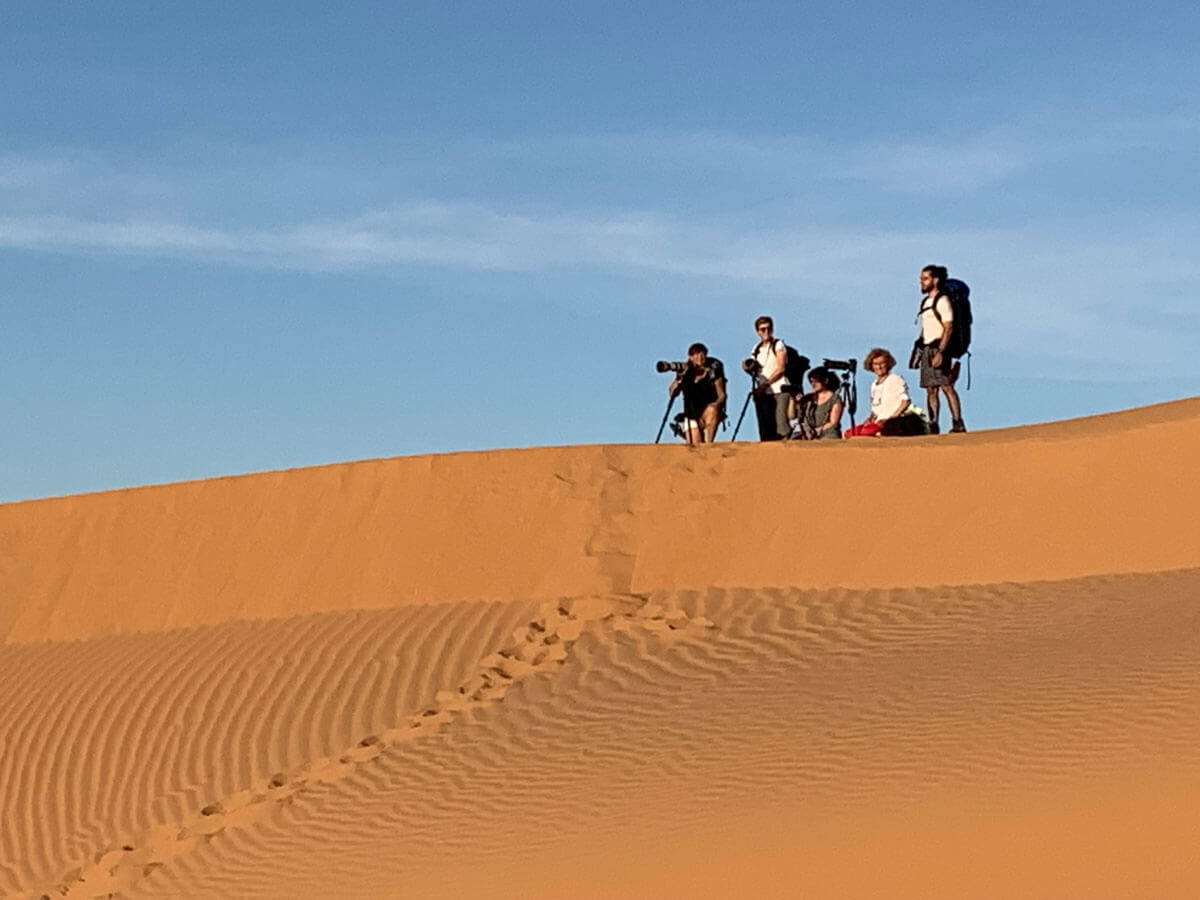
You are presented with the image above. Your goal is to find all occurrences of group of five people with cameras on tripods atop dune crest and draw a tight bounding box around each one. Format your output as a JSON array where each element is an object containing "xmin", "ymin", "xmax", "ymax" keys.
[{"xmin": 659, "ymin": 265, "xmax": 971, "ymax": 444}]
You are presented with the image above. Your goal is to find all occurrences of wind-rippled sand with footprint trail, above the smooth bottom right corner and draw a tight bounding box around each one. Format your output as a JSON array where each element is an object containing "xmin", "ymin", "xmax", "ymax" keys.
[{"xmin": 0, "ymin": 571, "xmax": 1200, "ymax": 898}]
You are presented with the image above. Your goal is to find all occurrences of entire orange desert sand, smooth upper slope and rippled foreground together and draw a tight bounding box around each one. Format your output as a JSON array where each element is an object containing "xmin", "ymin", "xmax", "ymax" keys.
[{"xmin": 0, "ymin": 400, "xmax": 1200, "ymax": 899}]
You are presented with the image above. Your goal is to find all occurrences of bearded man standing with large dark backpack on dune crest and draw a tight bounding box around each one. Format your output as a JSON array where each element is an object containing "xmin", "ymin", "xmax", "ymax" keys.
[{"xmin": 917, "ymin": 265, "xmax": 971, "ymax": 434}]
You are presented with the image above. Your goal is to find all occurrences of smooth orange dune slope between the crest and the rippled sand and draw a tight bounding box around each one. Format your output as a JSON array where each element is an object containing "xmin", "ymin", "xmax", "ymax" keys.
[{"xmin": 0, "ymin": 400, "xmax": 1200, "ymax": 642}]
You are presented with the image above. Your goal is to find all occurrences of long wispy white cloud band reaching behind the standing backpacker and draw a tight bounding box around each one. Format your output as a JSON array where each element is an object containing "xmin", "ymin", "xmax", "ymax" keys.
[{"xmin": 0, "ymin": 203, "xmax": 1200, "ymax": 367}]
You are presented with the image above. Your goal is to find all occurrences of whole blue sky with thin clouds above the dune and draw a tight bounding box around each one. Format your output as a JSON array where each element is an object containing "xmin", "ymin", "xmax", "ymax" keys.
[{"xmin": 0, "ymin": 1, "xmax": 1200, "ymax": 500}]
